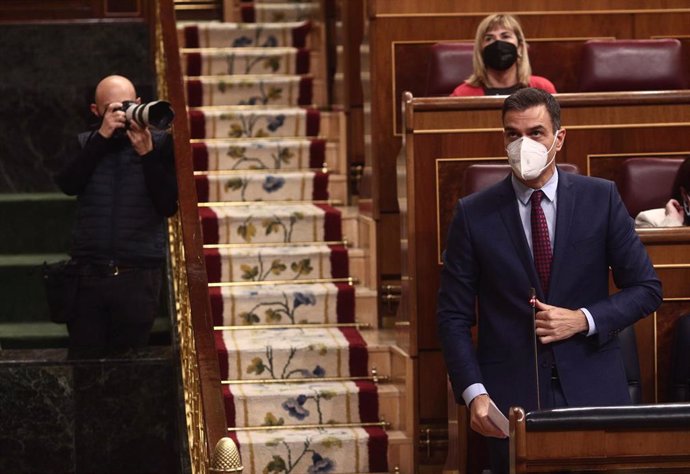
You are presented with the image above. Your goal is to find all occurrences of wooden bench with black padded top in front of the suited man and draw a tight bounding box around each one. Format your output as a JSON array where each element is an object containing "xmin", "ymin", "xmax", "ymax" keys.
[{"xmin": 510, "ymin": 404, "xmax": 690, "ymax": 474}]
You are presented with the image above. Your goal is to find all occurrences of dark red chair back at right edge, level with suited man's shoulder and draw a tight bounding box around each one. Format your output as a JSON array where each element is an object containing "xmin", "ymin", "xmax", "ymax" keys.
[{"xmin": 618, "ymin": 157, "xmax": 684, "ymax": 217}]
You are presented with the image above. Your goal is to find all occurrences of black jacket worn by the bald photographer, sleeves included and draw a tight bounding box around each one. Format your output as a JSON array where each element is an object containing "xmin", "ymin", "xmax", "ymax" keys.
[{"xmin": 57, "ymin": 132, "xmax": 177, "ymax": 266}]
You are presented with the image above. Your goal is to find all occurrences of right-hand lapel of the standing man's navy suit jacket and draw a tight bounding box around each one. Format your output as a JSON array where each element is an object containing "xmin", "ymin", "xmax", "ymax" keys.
[{"xmin": 549, "ymin": 171, "xmax": 576, "ymax": 301}]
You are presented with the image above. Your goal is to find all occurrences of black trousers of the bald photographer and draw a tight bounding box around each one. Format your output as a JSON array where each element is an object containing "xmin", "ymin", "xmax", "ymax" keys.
[{"xmin": 67, "ymin": 265, "xmax": 162, "ymax": 357}]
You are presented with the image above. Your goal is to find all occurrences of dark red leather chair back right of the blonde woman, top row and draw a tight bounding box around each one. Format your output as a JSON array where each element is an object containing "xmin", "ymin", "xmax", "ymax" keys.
[{"xmin": 579, "ymin": 39, "xmax": 688, "ymax": 92}]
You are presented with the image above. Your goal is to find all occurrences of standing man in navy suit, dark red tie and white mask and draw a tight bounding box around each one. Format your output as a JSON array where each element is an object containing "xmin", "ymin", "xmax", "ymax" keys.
[{"xmin": 437, "ymin": 88, "xmax": 661, "ymax": 474}]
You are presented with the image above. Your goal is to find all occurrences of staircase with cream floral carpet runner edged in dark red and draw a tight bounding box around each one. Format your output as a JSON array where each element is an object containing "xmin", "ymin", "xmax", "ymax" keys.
[{"xmin": 178, "ymin": 1, "xmax": 413, "ymax": 473}]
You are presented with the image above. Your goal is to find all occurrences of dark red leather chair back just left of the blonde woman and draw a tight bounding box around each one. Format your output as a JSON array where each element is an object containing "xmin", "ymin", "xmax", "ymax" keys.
[{"xmin": 425, "ymin": 43, "xmax": 474, "ymax": 96}]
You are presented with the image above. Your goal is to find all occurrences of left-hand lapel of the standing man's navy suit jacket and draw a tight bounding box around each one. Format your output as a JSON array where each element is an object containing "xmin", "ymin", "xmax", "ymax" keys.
[{"xmin": 497, "ymin": 175, "xmax": 544, "ymax": 292}]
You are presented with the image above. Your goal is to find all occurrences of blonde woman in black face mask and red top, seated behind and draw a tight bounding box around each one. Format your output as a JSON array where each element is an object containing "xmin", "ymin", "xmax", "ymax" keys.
[{"xmin": 451, "ymin": 13, "xmax": 556, "ymax": 96}]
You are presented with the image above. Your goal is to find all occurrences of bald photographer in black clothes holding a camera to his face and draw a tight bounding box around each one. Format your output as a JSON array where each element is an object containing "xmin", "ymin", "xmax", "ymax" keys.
[{"xmin": 57, "ymin": 76, "xmax": 177, "ymax": 355}]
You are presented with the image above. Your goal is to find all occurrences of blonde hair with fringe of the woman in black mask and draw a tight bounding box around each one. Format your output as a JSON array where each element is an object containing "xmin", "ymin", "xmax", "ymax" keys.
[{"xmin": 465, "ymin": 13, "xmax": 532, "ymax": 87}]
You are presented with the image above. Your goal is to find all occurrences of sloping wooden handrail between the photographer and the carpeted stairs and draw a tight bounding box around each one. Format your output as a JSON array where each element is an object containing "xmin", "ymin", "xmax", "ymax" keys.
[{"xmin": 156, "ymin": 0, "xmax": 227, "ymax": 472}]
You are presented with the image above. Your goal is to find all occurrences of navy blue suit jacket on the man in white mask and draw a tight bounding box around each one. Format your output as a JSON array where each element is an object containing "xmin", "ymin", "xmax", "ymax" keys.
[{"xmin": 437, "ymin": 172, "xmax": 661, "ymax": 413}]
